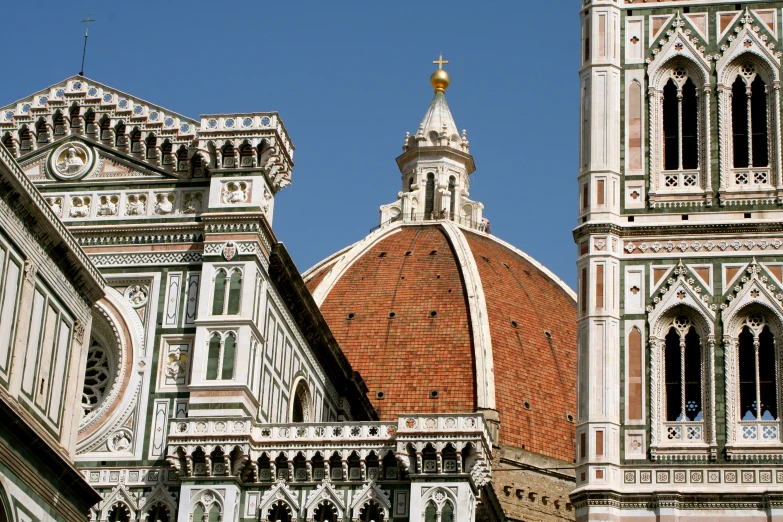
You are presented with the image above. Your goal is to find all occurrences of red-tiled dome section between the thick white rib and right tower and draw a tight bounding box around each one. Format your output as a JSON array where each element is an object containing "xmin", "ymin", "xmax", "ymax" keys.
[{"xmin": 463, "ymin": 231, "xmax": 577, "ymax": 463}]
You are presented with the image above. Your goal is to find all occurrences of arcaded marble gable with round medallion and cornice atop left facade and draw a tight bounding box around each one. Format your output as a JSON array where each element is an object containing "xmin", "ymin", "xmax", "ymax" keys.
[{"xmin": 0, "ymin": 76, "xmax": 294, "ymax": 193}]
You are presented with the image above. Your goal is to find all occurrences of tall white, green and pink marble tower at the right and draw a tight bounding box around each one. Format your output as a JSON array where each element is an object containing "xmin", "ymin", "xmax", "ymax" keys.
[{"xmin": 571, "ymin": 0, "xmax": 783, "ymax": 521}]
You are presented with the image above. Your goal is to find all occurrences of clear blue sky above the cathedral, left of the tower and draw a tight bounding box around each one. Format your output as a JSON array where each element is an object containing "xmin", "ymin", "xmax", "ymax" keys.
[{"xmin": 0, "ymin": 0, "xmax": 579, "ymax": 287}]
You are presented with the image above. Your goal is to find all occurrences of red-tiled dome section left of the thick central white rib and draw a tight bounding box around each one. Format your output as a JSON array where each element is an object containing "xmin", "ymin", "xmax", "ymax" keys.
[{"xmin": 318, "ymin": 226, "xmax": 475, "ymax": 419}]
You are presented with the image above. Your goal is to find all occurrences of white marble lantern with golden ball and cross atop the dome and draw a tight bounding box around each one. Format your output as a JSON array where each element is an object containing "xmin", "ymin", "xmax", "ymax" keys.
[{"xmin": 381, "ymin": 55, "xmax": 484, "ymax": 226}]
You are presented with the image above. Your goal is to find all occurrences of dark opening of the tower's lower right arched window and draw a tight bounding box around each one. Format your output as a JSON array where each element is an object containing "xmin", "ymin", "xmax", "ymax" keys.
[{"xmin": 738, "ymin": 314, "xmax": 778, "ymax": 421}]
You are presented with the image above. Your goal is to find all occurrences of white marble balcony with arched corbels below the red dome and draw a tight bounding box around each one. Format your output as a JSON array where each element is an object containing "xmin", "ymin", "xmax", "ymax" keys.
[{"xmin": 167, "ymin": 413, "xmax": 492, "ymax": 486}]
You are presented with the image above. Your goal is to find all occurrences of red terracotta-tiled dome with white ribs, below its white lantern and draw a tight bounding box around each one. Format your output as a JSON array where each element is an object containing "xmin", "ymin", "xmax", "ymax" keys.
[{"xmin": 305, "ymin": 220, "xmax": 577, "ymax": 462}]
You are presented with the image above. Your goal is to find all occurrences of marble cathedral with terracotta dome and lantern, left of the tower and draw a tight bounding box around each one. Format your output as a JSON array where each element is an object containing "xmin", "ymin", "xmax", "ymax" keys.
[{"xmin": 0, "ymin": 71, "xmax": 576, "ymax": 522}]
